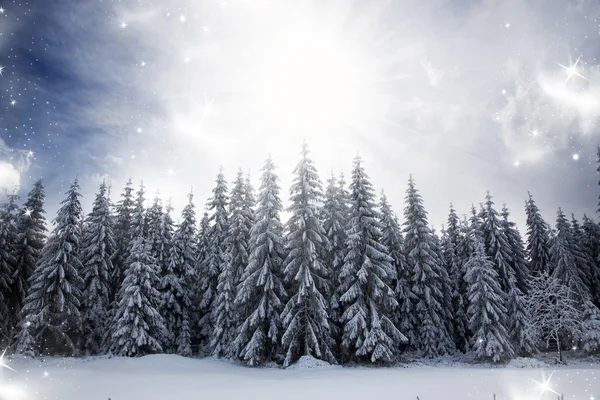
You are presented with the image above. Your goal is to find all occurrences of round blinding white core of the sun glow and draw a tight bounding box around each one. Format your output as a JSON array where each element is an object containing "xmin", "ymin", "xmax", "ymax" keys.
[{"xmin": 248, "ymin": 25, "xmax": 366, "ymax": 135}]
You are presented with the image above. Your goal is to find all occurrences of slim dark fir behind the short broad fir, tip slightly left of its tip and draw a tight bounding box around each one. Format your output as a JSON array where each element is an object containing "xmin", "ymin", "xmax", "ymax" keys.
[{"xmin": 111, "ymin": 179, "xmax": 135, "ymax": 301}]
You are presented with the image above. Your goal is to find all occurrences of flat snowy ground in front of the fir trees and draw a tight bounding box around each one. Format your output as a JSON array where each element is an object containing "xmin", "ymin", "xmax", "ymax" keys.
[{"xmin": 0, "ymin": 355, "xmax": 600, "ymax": 400}]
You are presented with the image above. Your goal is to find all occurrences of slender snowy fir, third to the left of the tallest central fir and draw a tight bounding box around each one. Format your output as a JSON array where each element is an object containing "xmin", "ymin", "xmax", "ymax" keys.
[{"xmin": 201, "ymin": 169, "xmax": 237, "ymax": 357}]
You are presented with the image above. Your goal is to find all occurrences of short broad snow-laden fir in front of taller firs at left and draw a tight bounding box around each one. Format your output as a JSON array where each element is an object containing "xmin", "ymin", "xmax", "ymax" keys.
[{"xmin": 110, "ymin": 235, "xmax": 165, "ymax": 357}]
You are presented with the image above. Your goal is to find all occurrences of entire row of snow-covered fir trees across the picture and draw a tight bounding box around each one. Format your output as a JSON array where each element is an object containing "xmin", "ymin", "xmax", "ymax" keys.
[{"xmin": 0, "ymin": 145, "xmax": 600, "ymax": 366}]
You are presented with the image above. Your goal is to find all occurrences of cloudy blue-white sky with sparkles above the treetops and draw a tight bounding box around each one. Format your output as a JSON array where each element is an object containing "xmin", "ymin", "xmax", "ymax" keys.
[{"xmin": 0, "ymin": 0, "xmax": 600, "ymax": 229}]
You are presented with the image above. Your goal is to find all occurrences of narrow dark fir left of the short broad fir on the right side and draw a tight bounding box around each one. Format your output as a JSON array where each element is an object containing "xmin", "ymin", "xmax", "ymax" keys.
[{"xmin": 442, "ymin": 204, "xmax": 470, "ymax": 352}]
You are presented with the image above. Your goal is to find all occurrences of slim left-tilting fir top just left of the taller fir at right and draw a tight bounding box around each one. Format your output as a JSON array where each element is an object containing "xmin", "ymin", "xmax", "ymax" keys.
[{"xmin": 501, "ymin": 204, "xmax": 531, "ymax": 294}]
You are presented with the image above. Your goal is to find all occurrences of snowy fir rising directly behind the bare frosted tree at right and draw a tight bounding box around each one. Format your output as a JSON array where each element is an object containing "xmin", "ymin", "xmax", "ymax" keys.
[{"xmin": 550, "ymin": 208, "xmax": 590, "ymax": 305}]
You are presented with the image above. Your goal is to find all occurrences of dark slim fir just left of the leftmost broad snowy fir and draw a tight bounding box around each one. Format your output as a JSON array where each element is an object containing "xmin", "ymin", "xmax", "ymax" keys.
[{"xmin": 9, "ymin": 179, "xmax": 47, "ymax": 336}]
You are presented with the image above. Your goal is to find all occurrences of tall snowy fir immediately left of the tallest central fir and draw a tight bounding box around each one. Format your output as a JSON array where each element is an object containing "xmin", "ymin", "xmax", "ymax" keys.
[{"xmin": 232, "ymin": 158, "xmax": 286, "ymax": 365}]
